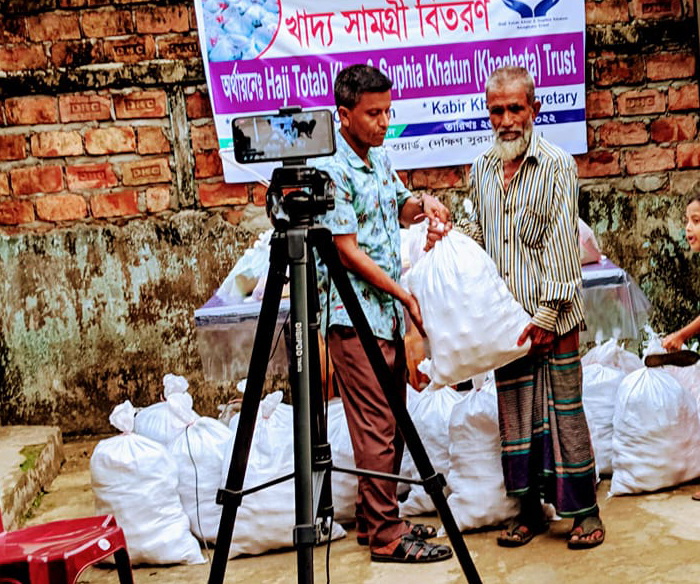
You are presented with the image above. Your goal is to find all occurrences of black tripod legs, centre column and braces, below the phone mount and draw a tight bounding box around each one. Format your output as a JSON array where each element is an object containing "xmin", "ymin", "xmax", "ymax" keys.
[{"xmin": 208, "ymin": 215, "xmax": 481, "ymax": 584}]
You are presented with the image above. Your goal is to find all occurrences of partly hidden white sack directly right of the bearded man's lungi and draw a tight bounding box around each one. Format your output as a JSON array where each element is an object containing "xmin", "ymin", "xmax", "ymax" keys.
[{"xmin": 583, "ymin": 363, "xmax": 625, "ymax": 474}]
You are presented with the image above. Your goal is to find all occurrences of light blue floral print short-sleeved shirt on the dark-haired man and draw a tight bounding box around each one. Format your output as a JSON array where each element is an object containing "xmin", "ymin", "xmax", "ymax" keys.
[{"xmin": 314, "ymin": 133, "xmax": 411, "ymax": 340}]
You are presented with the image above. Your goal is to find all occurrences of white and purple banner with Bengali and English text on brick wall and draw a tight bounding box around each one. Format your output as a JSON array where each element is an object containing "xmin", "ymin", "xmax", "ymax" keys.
[{"xmin": 195, "ymin": 0, "xmax": 587, "ymax": 182}]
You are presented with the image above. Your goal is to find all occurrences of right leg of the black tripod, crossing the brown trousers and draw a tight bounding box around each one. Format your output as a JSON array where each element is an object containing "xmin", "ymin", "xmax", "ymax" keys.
[{"xmin": 310, "ymin": 227, "xmax": 481, "ymax": 584}]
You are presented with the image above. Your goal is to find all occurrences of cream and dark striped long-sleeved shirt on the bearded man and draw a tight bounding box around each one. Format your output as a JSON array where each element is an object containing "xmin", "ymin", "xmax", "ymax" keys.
[{"xmin": 470, "ymin": 132, "xmax": 583, "ymax": 335}]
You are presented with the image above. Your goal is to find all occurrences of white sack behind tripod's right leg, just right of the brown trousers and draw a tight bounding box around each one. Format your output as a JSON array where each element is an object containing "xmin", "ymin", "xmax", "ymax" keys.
[{"xmin": 399, "ymin": 383, "xmax": 462, "ymax": 515}]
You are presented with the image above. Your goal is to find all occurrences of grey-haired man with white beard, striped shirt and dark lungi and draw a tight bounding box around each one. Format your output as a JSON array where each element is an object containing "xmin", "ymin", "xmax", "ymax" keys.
[{"xmin": 470, "ymin": 67, "xmax": 605, "ymax": 548}]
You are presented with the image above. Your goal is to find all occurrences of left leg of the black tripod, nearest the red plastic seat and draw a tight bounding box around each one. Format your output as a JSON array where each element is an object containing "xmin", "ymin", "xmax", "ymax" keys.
[{"xmin": 208, "ymin": 233, "xmax": 287, "ymax": 584}]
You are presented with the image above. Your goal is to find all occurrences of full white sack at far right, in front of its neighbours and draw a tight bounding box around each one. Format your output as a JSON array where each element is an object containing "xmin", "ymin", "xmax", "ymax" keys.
[{"xmin": 610, "ymin": 368, "xmax": 700, "ymax": 495}]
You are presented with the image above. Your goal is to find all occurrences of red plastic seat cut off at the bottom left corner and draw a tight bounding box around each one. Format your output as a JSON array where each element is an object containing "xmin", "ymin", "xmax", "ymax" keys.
[{"xmin": 0, "ymin": 515, "xmax": 134, "ymax": 584}]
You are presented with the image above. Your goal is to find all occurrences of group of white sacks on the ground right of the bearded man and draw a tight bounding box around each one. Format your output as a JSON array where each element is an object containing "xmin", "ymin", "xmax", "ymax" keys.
[{"xmin": 582, "ymin": 337, "xmax": 700, "ymax": 495}]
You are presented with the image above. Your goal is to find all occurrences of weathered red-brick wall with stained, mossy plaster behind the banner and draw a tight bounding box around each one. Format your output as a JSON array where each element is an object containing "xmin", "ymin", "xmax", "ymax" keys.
[{"xmin": 0, "ymin": 0, "xmax": 700, "ymax": 432}]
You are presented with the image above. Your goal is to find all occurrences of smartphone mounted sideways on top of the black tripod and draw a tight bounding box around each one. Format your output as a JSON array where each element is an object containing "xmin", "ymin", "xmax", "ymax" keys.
[{"xmin": 232, "ymin": 109, "xmax": 335, "ymax": 163}]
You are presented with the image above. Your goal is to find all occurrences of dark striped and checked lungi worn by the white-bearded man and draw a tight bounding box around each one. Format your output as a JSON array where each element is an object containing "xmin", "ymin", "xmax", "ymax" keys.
[{"xmin": 495, "ymin": 327, "xmax": 597, "ymax": 517}]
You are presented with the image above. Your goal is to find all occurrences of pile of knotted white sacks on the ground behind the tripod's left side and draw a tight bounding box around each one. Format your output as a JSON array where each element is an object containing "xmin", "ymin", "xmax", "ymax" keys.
[{"xmin": 90, "ymin": 374, "xmax": 350, "ymax": 564}]
